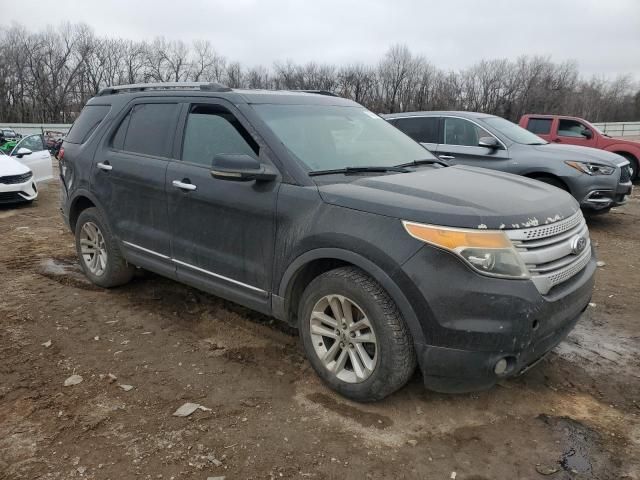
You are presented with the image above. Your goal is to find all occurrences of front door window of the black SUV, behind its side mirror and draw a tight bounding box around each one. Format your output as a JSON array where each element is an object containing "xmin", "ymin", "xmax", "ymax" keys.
[{"xmin": 182, "ymin": 105, "xmax": 258, "ymax": 166}]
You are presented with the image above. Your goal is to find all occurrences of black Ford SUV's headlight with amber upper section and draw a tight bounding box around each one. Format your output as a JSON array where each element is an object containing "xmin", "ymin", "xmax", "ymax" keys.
[{"xmin": 402, "ymin": 221, "xmax": 529, "ymax": 278}]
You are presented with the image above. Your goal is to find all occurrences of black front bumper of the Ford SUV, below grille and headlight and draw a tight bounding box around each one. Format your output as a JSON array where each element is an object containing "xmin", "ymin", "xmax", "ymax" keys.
[{"xmin": 403, "ymin": 247, "xmax": 596, "ymax": 393}]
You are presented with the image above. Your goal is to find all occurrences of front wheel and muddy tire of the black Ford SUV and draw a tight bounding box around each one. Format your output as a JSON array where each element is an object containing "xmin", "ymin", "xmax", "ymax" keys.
[{"xmin": 298, "ymin": 267, "xmax": 416, "ymax": 402}]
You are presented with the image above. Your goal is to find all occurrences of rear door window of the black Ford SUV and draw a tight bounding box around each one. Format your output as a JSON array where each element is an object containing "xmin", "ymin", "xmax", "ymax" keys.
[{"xmin": 112, "ymin": 103, "xmax": 178, "ymax": 157}]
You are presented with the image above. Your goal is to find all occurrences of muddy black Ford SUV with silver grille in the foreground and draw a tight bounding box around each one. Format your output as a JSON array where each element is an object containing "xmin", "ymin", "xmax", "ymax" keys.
[{"xmin": 60, "ymin": 83, "xmax": 595, "ymax": 401}]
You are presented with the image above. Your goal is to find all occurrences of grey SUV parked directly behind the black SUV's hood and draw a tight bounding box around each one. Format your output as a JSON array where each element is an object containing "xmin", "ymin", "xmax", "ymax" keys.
[{"xmin": 382, "ymin": 112, "xmax": 632, "ymax": 212}]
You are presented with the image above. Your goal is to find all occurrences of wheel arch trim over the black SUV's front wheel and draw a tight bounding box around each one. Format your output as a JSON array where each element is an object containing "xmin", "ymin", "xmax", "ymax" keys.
[{"xmin": 273, "ymin": 248, "xmax": 424, "ymax": 343}]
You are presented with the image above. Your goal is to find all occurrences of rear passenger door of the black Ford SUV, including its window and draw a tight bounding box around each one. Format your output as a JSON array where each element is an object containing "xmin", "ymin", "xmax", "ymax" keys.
[{"xmin": 91, "ymin": 98, "xmax": 181, "ymax": 276}]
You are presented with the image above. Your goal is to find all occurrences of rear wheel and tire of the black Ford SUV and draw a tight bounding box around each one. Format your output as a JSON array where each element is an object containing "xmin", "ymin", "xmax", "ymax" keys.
[{"xmin": 75, "ymin": 207, "xmax": 135, "ymax": 288}]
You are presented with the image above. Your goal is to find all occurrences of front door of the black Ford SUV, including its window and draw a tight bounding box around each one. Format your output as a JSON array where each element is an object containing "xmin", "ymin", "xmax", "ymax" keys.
[{"xmin": 166, "ymin": 100, "xmax": 279, "ymax": 312}]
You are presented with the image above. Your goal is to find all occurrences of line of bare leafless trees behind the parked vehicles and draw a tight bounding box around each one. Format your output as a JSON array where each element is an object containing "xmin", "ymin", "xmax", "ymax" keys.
[{"xmin": 0, "ymin": 24, "xmax": 640, "ymax": 123}]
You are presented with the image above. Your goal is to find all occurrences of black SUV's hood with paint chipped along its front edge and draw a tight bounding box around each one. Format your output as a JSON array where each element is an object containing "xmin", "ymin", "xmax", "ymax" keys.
[{"xmin": 318, "ymin": 166, "xmax": 579, "ymax": 229}]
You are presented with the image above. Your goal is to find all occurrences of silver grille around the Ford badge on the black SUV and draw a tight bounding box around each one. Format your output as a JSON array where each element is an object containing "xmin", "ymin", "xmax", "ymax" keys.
[{"xmin": 506, "ymin": 211, "xmax": 591, "ymax": 295}]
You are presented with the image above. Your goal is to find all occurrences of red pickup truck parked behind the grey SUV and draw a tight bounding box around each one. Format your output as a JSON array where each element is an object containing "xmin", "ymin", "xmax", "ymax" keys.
[{"xmin": 520, "ymin": 114, "xmax": 640, "ymax": 180}]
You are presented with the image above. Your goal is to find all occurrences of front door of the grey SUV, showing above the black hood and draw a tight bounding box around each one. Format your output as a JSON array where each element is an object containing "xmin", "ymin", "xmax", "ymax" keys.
[{"xmin": 436, "ymin": 117, "xmax": 513, "ymax": 172}]
